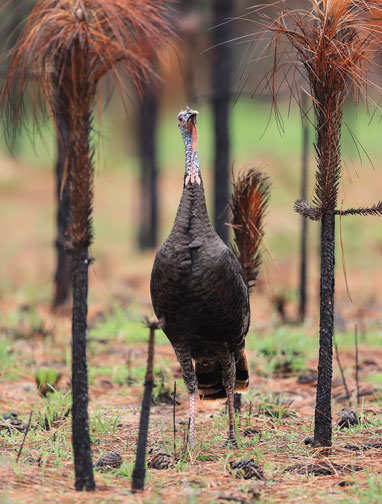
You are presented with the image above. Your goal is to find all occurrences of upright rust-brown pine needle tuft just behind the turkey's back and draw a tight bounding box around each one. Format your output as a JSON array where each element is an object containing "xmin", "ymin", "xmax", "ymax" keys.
[{"xmin": 230, "ymin": 168, "xmax": 270, "ymax": 291}]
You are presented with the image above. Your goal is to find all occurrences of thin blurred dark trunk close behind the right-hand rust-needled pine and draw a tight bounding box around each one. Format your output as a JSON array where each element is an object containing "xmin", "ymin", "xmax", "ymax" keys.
[{"xmin": 298, "ymin": 93, "xmax": 309, "ymax": 322}]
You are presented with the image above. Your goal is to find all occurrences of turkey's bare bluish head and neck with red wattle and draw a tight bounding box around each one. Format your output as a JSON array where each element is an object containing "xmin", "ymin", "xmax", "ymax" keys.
[{"xmin": 178, "ymin": 107, "xmax": 201, "ymax": 185}]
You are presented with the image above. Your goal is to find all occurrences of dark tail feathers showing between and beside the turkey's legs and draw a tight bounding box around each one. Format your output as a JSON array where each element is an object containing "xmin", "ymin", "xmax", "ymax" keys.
[{"xmin": 195, "ymin": 351, "xmax": 249, "ymax": 401}]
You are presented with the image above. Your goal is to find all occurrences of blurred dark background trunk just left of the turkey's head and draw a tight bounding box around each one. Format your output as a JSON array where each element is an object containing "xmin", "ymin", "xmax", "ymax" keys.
[{"xmin": 138, "ymin": 86, "xmax": 158, "ymax": 250}]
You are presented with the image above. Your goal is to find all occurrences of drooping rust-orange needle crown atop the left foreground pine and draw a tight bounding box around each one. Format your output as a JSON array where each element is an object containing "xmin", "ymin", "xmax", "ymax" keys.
[{"xmin": 0, "ymin": 0, "xmax": 173, "ymax": 135}]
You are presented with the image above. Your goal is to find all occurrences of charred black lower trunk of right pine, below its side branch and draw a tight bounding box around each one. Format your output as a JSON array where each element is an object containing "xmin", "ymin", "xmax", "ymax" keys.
[{"xmin": 314, "ymin": 212, "xmax": 335, "ymax": 446}]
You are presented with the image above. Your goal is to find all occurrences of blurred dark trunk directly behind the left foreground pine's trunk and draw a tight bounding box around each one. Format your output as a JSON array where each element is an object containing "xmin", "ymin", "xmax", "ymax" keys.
[{"xmin": 53, "ymin": 113, "xmax": 72, "ymax": 308}]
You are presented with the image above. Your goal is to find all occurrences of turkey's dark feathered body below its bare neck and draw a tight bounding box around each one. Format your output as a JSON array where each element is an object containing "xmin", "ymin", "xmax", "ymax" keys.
[{"xmin": 151, "ymin": 177, "xmax": 250, "ymax": 399}]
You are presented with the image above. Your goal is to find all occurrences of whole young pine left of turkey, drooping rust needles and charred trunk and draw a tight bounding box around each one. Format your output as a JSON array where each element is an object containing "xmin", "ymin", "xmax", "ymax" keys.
[{"xmin": 0, "ymin": 0, "xmax": 171, "ymax": 490}]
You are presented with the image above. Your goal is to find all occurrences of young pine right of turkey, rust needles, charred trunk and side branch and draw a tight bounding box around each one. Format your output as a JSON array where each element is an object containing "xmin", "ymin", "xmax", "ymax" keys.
[{"xmin": 245, "ymin": 0, "xmax": 382, "ymax": 447}]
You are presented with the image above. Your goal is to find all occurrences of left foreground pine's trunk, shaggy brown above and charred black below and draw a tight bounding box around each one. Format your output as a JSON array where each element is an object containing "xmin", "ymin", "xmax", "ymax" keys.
[{"xmin": 54, "ymin": 43, "xmax": 95, "ymax": 491}]
